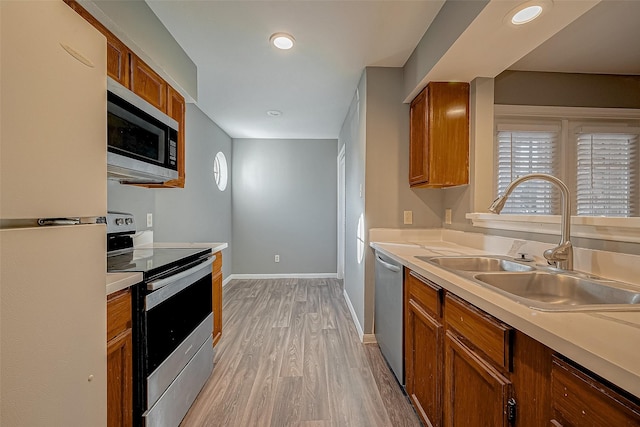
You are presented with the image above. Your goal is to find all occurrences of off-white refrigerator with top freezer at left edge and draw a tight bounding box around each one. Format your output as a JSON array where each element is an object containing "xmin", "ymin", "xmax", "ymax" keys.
[{"xmin": 0, "ymin": 0, "xmax": 107, "ymax": 427}]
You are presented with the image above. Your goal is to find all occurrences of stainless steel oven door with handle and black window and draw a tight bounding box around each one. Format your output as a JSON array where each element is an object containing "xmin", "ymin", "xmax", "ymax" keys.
[{"xmin": 143, "ymin": 255, "xmax": 215, "ymax": 410}]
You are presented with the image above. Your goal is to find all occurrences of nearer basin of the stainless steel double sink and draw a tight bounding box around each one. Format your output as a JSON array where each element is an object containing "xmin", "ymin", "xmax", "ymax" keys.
[{"xmin": 473, "ymin": 271, "xmax": 640, "ymax": 311}]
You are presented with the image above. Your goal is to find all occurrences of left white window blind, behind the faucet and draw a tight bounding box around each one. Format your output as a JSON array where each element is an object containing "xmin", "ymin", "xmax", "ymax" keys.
[{"xmin": 496, "ymin": 124, "xmax": 560, "ymax": 215}]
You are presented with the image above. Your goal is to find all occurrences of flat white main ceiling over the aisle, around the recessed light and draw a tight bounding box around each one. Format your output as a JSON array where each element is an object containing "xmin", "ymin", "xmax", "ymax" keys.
[{"xmin": 147, "ymin": 0, "xmax": 444, "ymax": 139}]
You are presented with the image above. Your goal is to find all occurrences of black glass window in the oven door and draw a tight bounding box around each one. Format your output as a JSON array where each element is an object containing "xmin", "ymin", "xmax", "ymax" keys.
[{"xmin": 146, "ymin": 274, "xmax": 212, "ymax": 373}]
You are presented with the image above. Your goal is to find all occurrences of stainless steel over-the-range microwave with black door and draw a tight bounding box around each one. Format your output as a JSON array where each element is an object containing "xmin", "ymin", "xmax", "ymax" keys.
[{"xmin": 107, "ymin": 78, "xmax": 178, "ymax": 183}]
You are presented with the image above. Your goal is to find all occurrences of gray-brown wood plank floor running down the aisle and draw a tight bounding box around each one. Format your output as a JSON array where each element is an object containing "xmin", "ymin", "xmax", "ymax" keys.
[{"xmin": 181, "ymin": 279, "xmax": 420, "ymax": 427}]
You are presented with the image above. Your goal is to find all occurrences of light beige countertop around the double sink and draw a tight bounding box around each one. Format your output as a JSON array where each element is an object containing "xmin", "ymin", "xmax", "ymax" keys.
[{"xmin": 370, "ymin": 232, "xmax": 640, "ymax": 397}]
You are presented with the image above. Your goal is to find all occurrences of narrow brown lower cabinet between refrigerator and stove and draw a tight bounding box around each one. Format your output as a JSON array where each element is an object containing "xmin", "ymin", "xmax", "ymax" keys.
[{"xmin": 107, "ymin": 289, "xmax": 133, "ymax": 427}]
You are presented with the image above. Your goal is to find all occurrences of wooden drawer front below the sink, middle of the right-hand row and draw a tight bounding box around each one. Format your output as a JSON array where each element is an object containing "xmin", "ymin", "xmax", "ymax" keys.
[{"xmin": 444, "ymin": 294, "xmax": 512, "ymax": 370}]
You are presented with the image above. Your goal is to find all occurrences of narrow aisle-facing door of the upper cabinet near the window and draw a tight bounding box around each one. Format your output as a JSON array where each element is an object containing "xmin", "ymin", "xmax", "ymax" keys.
[{"xmin": 409, "ymin": 88, "xmax": 429, "ymax": 185}]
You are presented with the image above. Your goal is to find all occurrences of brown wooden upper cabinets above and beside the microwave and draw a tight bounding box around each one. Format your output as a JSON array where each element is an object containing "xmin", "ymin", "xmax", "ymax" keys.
[{"xmin": 64, "ymin": 0, "xmax": 185, "ymax": 188}]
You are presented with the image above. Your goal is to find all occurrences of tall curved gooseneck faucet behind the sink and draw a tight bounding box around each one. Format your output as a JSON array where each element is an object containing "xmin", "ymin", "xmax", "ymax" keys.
[{"xmin": 489, "ymin": 173, "xmax": 573, "ymax": 270}]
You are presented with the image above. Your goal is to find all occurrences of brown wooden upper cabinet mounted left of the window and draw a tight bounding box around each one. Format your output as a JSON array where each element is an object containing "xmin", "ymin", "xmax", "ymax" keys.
[{"xmin": 409, "ymin": 82, "xmax": 469, "ymax": 188}]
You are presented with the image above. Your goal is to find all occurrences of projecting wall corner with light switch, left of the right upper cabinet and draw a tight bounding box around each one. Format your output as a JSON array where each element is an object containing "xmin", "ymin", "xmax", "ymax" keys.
[{"xmin": 339, "ymin": 67, "xmax": 444, "ymax": 340}]
